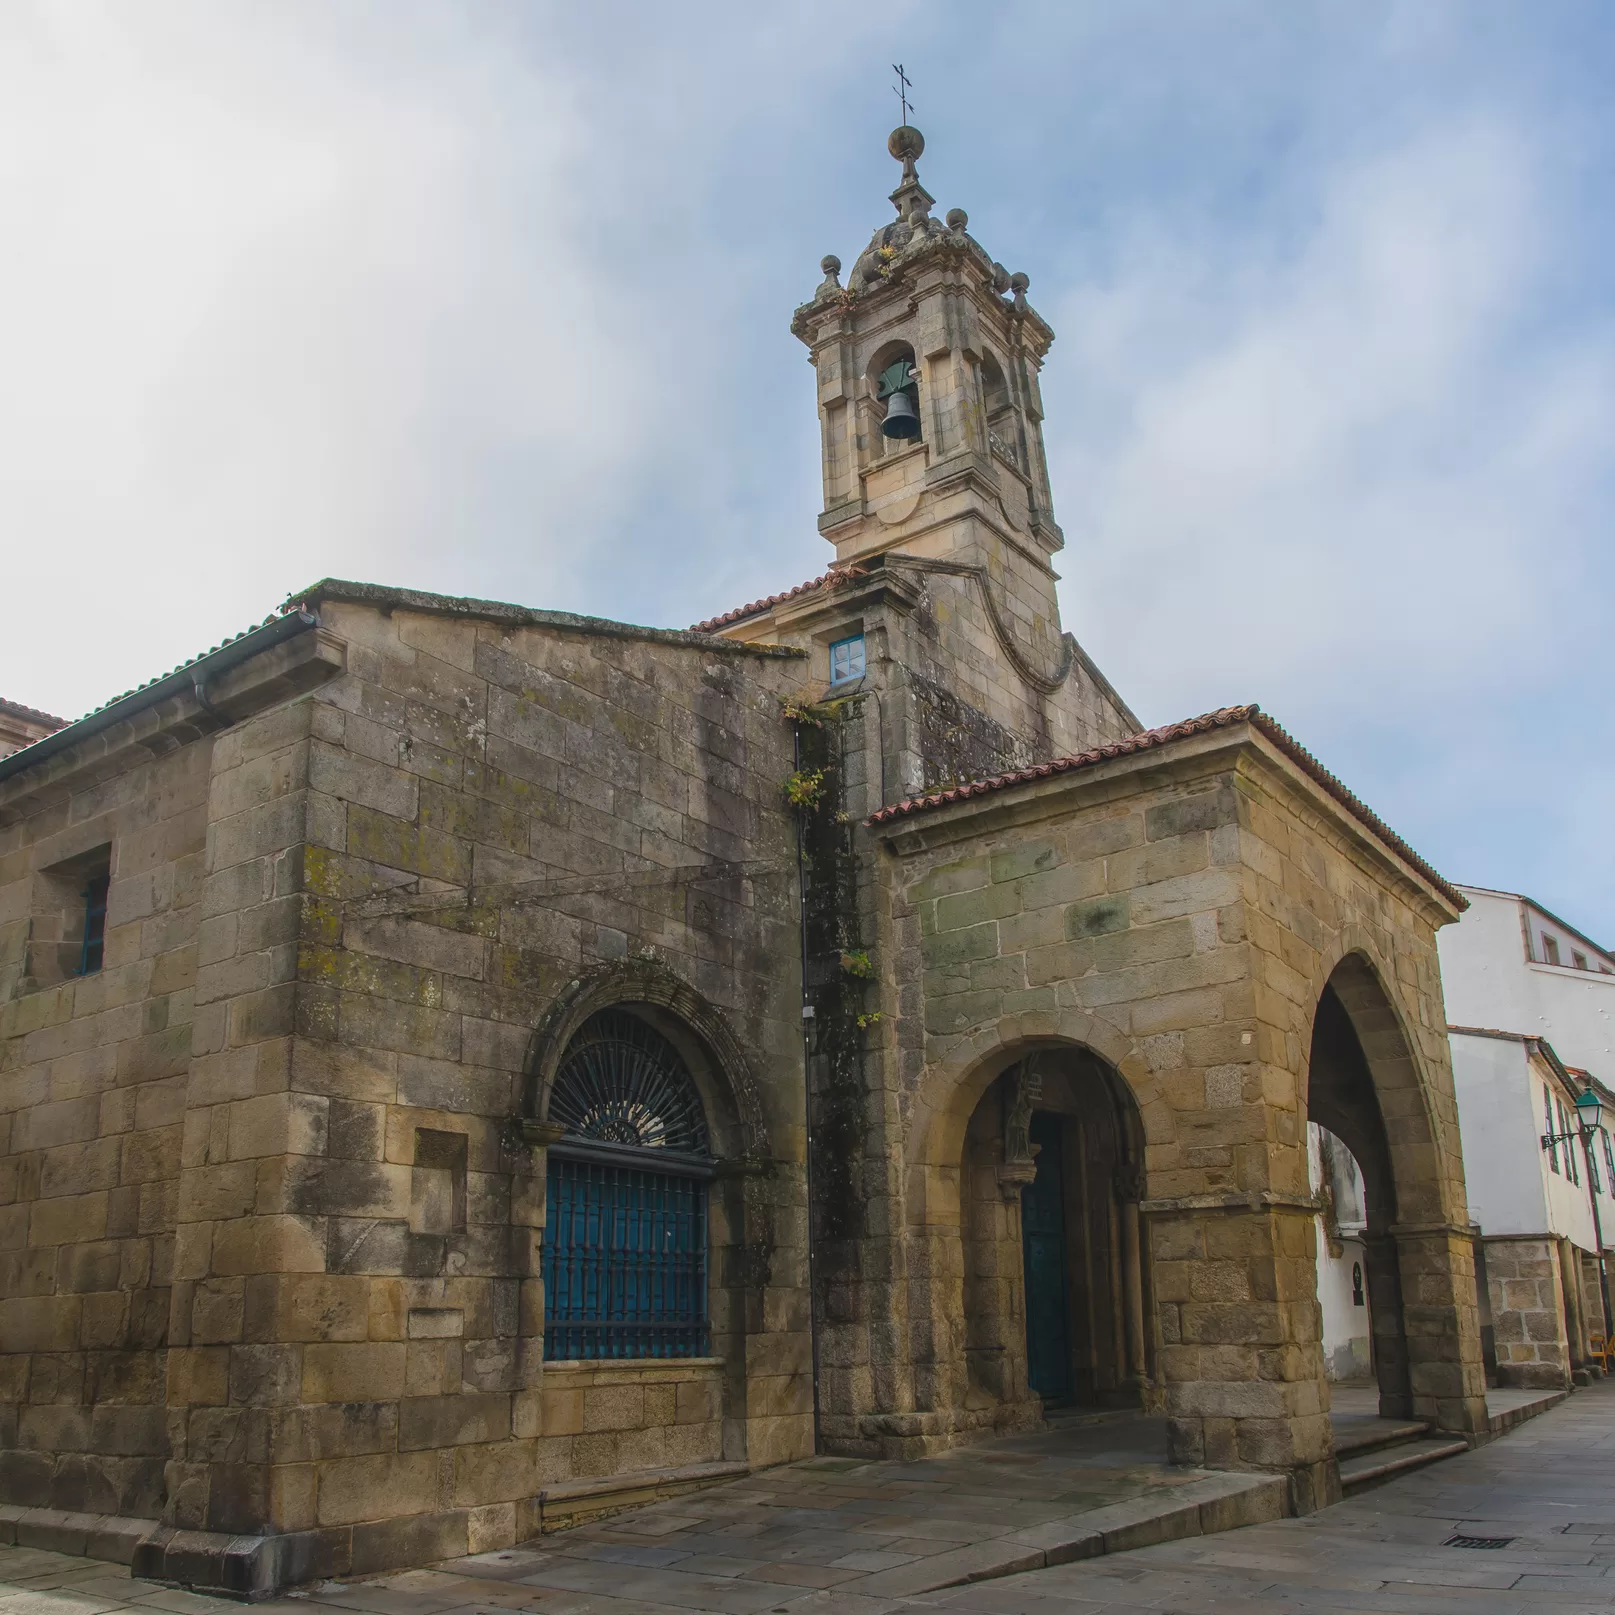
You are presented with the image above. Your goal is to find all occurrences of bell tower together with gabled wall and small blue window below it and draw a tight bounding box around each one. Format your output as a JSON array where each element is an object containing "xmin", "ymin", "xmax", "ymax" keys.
[{"xmin": 698, "ymin": 124, "xmax": 1143, "ymax": 812}]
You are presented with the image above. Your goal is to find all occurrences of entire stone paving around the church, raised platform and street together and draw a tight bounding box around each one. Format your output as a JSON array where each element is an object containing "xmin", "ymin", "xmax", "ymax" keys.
[{"xmin": 0, "ymin": 1381, "xmax": 1595, "ymax": 1615}]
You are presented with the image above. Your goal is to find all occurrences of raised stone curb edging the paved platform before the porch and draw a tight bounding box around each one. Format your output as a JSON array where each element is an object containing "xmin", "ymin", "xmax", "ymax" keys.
[{"xmin": 838, "ymin": 1474, "xmax": 1290, "ymax": 1597}]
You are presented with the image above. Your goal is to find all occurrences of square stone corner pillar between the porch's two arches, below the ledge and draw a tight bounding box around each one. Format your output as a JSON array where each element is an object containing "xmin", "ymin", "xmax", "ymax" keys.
[{"xmin": 1148, "ymin": 1197, "xmax": 1340, "ymax": 1513}]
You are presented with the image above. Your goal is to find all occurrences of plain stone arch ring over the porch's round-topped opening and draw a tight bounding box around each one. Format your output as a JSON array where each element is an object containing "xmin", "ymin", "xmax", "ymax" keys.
[{"xmin": 906, "ymin": 1009, "xmax": 1172, "ymax": 1168}]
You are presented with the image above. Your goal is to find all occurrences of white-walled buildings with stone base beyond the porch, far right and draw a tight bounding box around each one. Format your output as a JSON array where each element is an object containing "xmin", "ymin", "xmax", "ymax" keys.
[{"xmin": 1437, "ymin": 887, "xmax": 1615, "ymax": 1386}]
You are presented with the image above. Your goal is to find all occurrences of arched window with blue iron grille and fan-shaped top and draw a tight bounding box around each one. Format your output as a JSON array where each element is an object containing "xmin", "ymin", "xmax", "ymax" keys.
[{"xmin": 544, "ymin": 1008, "xmax": 712, "ymax": 1360}]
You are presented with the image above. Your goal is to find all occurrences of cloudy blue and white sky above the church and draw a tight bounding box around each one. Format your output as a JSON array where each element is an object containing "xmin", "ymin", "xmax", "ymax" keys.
[{"xmin": 0, "ymin": 0, "xmax": 1615, "ymax": 942}]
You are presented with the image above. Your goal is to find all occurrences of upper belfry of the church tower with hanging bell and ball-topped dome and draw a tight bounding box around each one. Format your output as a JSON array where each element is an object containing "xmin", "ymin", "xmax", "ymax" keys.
[{"xmin": 791, "ymin": 124, "xmax": 1064, "ymax": 620}]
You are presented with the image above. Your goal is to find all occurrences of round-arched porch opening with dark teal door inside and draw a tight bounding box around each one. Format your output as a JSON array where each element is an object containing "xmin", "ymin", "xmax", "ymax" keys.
[{"xmin": 959, "ymin": 1045, "xmax": 1148, "ymax": 1416}]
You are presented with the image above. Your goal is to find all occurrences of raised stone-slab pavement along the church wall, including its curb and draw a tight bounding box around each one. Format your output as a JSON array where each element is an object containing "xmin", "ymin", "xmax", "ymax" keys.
[{"xmin": 0, "ymin": 1415, "xmax": 1286, "ymax": 1615}]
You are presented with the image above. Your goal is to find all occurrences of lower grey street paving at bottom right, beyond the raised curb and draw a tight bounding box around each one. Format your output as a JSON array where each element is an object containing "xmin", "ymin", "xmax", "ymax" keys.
[{"xmin": 923, "ymin": 1379, "xmax": 1615, "ymax": 1615}]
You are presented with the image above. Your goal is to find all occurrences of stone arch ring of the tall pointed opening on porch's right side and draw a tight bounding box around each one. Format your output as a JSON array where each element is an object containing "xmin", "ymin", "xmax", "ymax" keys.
[{"xmin": 1300, "ymin": 924, "xmax": 1463, "ymax": 1223}]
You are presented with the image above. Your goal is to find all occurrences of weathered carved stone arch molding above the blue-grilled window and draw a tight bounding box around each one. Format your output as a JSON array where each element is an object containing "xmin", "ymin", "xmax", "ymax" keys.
[{"xmin": 525, "ymin": 959, "xmax": 769, "ymax": 1161}]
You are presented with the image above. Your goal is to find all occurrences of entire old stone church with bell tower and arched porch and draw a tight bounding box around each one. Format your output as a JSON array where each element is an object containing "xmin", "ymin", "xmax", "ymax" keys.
[{"xmin": 0, "ymin": 128, "xmax": 1486, "ymax": 1597}]
